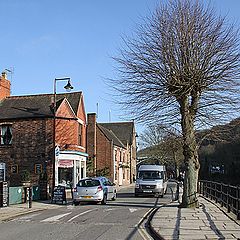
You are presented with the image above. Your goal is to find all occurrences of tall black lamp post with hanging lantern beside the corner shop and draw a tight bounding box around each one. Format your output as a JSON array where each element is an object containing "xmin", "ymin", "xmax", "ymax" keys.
[{"xmin": 52, "ymin": 77, "xmax": 73, "ymax": 198}]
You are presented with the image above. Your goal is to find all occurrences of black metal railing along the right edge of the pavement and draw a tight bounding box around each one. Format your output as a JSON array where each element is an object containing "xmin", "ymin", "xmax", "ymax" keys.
[{"xmin": 199, "ymin": 181, "xmax": 240, "ymax": 220}]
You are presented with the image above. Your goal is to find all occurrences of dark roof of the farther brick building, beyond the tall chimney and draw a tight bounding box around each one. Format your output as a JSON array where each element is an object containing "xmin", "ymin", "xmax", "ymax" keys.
[{"xmin": 99, "ymin": 122, "xmax": 134, "ymax": 145}]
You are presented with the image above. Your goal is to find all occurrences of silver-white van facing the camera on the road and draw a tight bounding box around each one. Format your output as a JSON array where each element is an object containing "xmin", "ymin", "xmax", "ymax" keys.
[{"xmin": 135, "ymin": 165, "xmax": 167, "ymax": 197}]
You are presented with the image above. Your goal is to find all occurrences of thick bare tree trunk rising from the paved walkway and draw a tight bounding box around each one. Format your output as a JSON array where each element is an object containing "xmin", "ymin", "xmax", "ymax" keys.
[{"xmin": 180, "ymin": 98, "xmax": 200, "ymax": 208}]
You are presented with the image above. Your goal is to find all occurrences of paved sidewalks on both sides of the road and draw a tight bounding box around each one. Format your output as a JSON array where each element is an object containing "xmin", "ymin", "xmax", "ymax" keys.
[{"xmin": 0, "ymin": 188, "xmax": 240, "ymax": 240}]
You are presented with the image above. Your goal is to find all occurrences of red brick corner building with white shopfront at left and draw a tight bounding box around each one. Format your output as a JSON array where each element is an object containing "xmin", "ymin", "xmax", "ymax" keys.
[{"xmin": 0, "ymin": 73, "xmax": 87, "ymax": 192}]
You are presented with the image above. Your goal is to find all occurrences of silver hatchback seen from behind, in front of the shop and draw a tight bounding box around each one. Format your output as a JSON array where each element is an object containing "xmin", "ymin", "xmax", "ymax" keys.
[{"xmin": 73, "ymin": 177, "xmax": 117, "ymax": 205}]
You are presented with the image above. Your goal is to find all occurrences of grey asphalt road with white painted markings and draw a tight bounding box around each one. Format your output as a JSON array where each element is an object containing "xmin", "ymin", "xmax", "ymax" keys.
[{"xmin": 0, "ymin": 183, "xmax": 176, "ymax": 240}]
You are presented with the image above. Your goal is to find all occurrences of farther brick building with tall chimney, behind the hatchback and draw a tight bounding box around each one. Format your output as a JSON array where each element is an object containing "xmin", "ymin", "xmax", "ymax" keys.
[{"xmin": 87, "ymin": 113, "xmax": 136, "ymax": 186}]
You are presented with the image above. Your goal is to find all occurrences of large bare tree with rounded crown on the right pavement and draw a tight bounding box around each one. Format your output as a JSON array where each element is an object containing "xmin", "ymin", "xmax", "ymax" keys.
[{"xmin": 111, "ymin": 0, "xmax": 240, "ymax": 207}]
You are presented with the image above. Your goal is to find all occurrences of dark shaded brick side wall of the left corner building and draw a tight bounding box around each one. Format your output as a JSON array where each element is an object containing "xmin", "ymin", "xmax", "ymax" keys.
[{"xmin": 0, "ymin": 119, "xmax": 53, "ymax": 185}]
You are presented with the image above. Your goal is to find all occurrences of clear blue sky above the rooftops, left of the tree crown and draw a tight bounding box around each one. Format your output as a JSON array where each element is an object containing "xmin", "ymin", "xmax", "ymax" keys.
[{"xmin": 0, "ymin": 0, "xmax": 240, "ymax": 135}]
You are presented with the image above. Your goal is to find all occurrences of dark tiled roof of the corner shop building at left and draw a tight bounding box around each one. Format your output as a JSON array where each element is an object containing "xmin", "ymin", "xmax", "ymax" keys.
[{"xmin": 0, "ymin": 92, "xmax": 82, "ymax": 120}]
